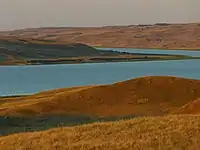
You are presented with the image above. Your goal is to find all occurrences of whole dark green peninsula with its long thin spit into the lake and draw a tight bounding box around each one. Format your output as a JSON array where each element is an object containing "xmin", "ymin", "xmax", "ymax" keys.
[{"xmin": 0, "ymin": 37, "xmax": 190, "ymax": 65}]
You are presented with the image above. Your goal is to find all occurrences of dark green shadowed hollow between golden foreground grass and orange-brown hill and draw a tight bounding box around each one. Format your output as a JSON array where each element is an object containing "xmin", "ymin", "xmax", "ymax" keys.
[{"xmin": 0, "ymin": 115, "xmax": 135, "ymax": 136}]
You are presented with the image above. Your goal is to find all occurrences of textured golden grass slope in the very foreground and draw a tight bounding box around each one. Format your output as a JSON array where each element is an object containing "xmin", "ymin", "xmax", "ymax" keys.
[{"xmin": 0, "ymin": 116, "xmax": 200, "ymax": 150}]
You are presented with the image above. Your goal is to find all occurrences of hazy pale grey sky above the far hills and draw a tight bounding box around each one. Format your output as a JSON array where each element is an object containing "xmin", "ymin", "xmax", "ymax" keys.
[{"xmin": 0, "ymin": 0, "xmax": 200, "ymax": 30}]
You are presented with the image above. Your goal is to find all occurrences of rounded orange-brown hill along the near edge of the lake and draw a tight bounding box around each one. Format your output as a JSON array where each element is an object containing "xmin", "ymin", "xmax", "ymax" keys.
[{"xmin": 0, "ymin": 76, "xmax": 200, "ymax": 116}]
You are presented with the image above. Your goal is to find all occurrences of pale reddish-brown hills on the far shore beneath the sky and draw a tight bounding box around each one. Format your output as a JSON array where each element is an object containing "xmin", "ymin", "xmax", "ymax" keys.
[{"xmin": 0, "ymin": 23, "xmax": 200, "ymax": 49}]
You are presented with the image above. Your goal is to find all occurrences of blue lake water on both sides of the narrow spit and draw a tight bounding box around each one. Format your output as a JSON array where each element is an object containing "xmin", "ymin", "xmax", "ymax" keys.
[{"xmin": 0, "ymin": 49, "xmax": 200, "ymax": 96}]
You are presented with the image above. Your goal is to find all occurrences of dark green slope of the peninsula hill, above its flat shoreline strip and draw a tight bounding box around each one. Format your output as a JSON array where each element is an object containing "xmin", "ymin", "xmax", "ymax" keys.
[{"xmin": 0, "ymin": 38, "xmax": 120, "ymax": 59}]
